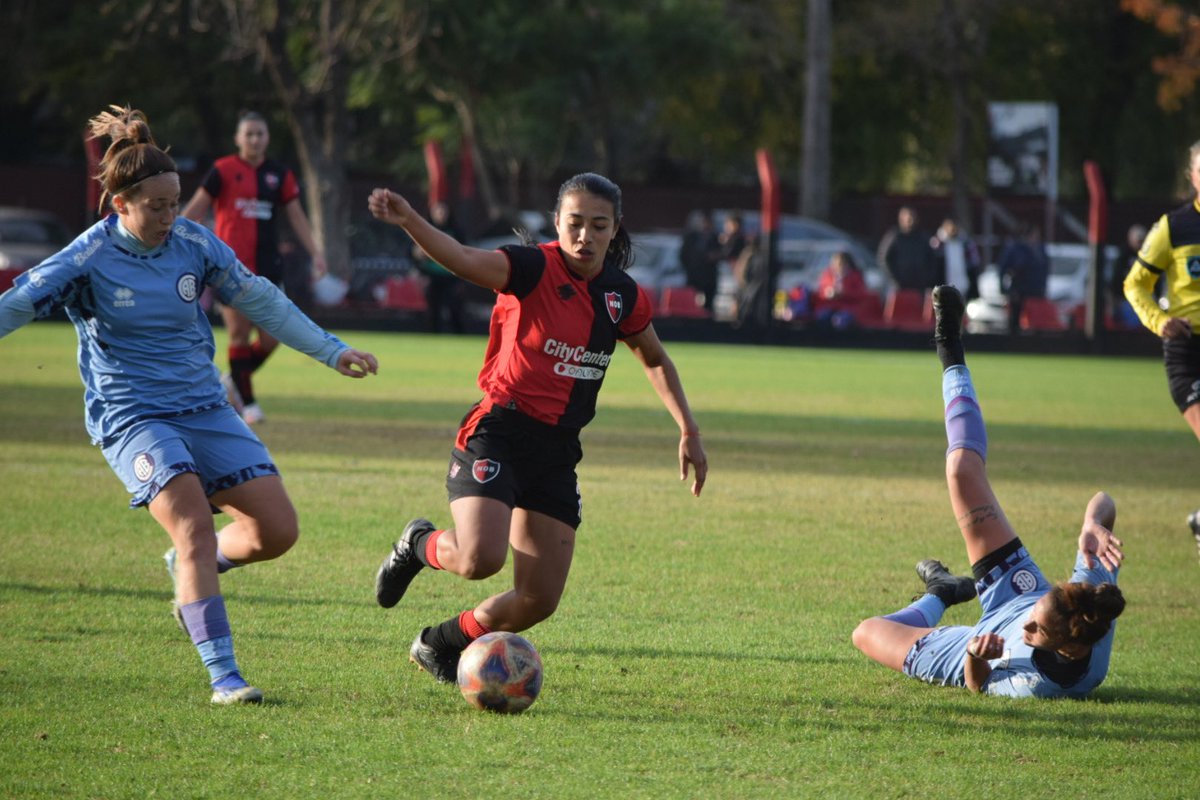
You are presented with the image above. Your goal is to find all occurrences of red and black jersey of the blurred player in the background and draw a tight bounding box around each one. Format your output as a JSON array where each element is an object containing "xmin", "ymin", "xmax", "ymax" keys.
[{"xmin": 204, "ymin": 155, "xmax": 300, "ymax": 272}]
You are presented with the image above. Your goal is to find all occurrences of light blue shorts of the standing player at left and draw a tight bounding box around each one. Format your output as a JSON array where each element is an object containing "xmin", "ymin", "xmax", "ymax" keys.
[{"xmin": 102, "ymin": 405, "xmax": 280, "ymax": 509}]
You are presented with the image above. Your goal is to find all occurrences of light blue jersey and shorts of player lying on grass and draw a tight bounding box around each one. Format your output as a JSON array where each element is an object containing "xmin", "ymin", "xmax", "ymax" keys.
[{"xmin": 904, "ymin": 547, "xmax": 1117, "ymax": 697}]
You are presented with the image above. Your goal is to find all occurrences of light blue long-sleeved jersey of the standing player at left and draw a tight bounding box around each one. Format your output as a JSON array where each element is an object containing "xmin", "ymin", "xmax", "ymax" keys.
[{"xmin": 0, "ymin": 213, "xmax": 347, "ymax": 445}]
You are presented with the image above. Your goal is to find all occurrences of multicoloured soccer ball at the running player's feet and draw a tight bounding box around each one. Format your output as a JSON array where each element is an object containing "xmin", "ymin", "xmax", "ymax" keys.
[{"xmin": 458, "ymin": 631, "xmax": 541, "ymax": 714}]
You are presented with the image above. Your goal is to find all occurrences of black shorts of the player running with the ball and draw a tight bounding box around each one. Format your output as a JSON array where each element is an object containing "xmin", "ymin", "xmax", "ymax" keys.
[{"xmin": 446, "ymin": 408, "xmax": 583, "ymax": 529}]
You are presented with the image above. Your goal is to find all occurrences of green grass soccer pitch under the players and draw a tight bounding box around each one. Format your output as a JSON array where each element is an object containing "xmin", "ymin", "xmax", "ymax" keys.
[{"xmin": 0, "ymin": 323, "xmax": 1200, "ymax": 799}]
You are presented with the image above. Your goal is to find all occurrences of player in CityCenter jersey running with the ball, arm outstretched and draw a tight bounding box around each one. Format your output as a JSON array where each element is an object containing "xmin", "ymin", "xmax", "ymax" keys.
[{"xmin": 368, "ymin": 173, "xmax": 708, "ymax": 682}]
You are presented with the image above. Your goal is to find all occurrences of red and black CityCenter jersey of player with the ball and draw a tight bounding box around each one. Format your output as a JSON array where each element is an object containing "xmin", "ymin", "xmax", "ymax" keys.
[{"xmin": 479, "ymin": 242, "xmax": 652, "ymax": 429}]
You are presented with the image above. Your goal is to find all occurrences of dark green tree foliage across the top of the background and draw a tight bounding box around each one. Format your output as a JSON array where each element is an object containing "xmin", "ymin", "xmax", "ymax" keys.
[{"xmin": 0, "ymin": 0, "xmax": 1200, "ymax": 204}]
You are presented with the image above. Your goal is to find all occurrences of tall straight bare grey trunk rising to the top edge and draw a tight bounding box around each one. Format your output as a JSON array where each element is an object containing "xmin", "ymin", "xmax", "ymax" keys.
[{"xmin": 800, "ymin": 0, "xmax": 833, "ymax": 219}]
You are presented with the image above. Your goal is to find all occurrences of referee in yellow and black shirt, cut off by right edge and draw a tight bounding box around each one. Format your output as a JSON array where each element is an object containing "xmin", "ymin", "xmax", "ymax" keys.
[{"xmin": 1124, "ymin": 142, "xmax": 1200, "ymax": 556}]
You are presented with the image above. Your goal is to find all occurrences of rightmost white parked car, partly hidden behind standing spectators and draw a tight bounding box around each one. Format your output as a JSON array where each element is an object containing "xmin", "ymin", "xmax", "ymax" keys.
[{"xmin": 967, "ymin": 242, "xmax": 1120, "ymax": 333}]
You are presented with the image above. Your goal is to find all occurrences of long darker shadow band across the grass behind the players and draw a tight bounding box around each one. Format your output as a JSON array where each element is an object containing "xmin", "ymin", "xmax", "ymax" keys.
[{"xmin": 0, "ymin": 386, "xmax": 1194, "ymax": 491}]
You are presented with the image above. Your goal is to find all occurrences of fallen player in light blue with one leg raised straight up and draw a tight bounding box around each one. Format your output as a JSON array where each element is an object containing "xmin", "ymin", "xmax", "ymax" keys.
[{"xmin": 853, "ymin": 285, "xmax": 1124, "ymax": 697}]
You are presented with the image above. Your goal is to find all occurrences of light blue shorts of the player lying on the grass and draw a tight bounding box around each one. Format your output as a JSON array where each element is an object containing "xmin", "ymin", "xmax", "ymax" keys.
[{"xmin": 904, "ymin": 547, "xmax": 1050, "ymax": 686}]
